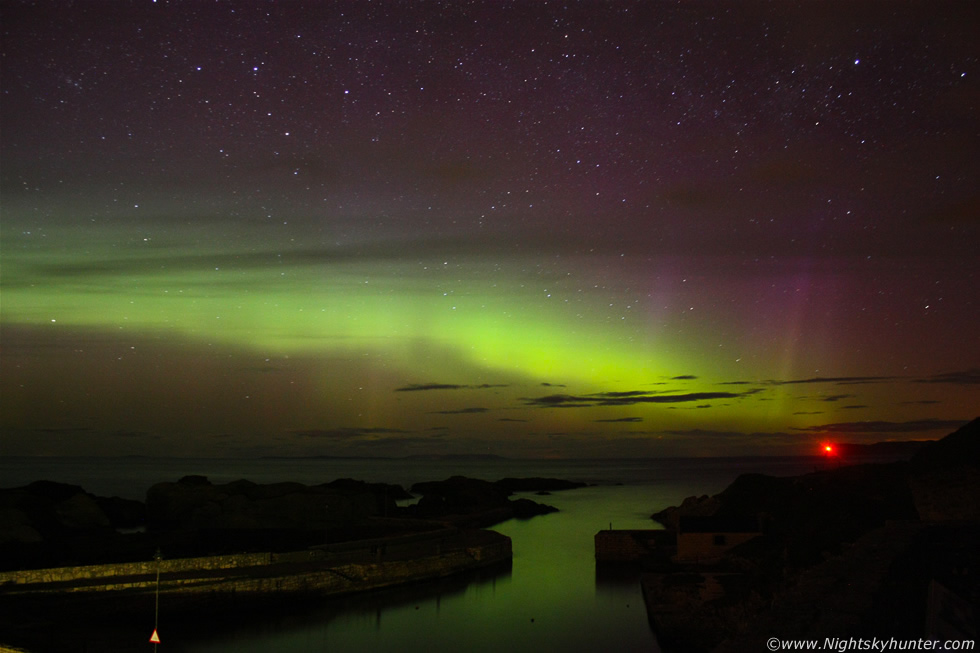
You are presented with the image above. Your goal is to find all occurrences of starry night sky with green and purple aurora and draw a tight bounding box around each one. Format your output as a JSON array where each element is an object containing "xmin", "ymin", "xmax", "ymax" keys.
[{"xmin": 0, "ymin": 0, "xmax": 980, "ymax": 457}]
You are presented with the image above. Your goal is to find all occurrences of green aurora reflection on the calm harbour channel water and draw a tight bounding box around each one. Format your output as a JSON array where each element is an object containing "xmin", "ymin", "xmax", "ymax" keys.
[{"xmin": 182, "ymin": 486, "xmax": 658, "ymax": 653}]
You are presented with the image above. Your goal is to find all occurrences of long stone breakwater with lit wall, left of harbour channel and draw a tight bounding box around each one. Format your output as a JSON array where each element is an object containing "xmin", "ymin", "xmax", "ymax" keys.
[{"xmin": 0, "ymin": 528, "xmax": 512, "ymax": 598}]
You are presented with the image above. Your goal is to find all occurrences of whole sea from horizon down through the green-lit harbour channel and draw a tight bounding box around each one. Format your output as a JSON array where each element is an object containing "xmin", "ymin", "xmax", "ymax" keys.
[{"xmin": 0, "ymin": 457, "xmax": 852, "ymax": 653}]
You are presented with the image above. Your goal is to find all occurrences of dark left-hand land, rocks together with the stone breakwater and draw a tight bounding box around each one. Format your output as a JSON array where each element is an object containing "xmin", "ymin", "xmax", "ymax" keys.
[{"xmin": 0, "ymin": 476, "xmax": 581, "ymax": 651}]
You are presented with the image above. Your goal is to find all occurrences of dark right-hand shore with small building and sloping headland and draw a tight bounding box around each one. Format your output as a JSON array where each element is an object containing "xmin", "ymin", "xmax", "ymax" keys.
[{"xmin": 641, "ymin": 419, "xmax": 980, "ymax": 653}]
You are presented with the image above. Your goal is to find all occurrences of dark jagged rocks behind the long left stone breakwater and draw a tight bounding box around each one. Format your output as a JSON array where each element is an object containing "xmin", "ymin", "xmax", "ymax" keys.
[{"xmin": 0, "ymin": 476, "xmax": 576, "ymax": 571}]
